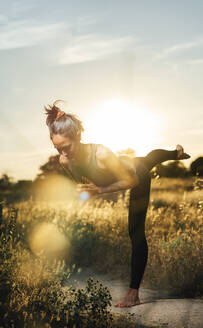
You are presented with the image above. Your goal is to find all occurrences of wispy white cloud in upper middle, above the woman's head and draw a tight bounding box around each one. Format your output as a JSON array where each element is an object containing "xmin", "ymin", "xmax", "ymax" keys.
[{"xmin": 58, "ymin": 34, "xmax": 135, "ymax": 65}]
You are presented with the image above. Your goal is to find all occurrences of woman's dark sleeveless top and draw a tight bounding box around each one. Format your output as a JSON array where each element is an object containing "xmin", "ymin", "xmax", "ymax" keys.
[{"xmin": 61, "ymin": 144, "xmax": 133, "ymax": 187}]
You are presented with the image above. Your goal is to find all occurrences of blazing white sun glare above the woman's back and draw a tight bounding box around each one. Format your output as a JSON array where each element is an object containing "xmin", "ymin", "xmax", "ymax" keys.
[{"xmin": 83, "ymin": 99, "xmax": 160, "ymax": 156}]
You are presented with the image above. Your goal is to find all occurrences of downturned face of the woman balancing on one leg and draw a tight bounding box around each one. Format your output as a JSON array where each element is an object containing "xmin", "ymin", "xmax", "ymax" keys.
[{"xmin": 51, "ymin": 134, "xmax": 80, "ymax": 159}]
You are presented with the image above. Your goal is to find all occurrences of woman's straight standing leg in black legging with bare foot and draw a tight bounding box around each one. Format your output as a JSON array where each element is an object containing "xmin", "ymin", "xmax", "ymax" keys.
[{"xmin": 116, "ymin": 164, "xmax": 151, "ymax": 307}]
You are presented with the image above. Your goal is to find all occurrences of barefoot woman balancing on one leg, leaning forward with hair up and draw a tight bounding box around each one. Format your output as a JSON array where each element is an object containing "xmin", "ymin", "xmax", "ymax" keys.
[{"xmin": 45, "ymin": 102, "xmax": 190, "ymax": 307}]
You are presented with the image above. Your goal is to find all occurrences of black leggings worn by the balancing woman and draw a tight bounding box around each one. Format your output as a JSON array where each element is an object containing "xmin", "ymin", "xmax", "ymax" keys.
[{"xmin": 128, "ymin": 149, "xmax": 177, "ymax": 289}]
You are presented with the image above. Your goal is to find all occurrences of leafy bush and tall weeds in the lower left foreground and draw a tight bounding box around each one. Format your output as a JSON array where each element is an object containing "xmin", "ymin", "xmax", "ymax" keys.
[{"xmin": 0, "ymin": 209, "xmax": 112, "ymax": 328}]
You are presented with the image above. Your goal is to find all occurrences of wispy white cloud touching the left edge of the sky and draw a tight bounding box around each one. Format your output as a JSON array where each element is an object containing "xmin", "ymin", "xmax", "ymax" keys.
[{"xmin": 0, "ymin": 20, "xmax": 66, "ymax": 50}]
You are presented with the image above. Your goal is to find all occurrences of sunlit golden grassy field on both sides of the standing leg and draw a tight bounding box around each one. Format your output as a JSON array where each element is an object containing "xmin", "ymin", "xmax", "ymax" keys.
[{"xmin": 0, "ymin": 178, "xmax": 203, "ymax": 327}]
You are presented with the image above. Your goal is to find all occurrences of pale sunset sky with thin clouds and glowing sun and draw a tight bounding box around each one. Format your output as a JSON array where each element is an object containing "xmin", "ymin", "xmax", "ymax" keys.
[{"xmin": 0, "ymin": 0, "xmax": 203, "ymax": 180}]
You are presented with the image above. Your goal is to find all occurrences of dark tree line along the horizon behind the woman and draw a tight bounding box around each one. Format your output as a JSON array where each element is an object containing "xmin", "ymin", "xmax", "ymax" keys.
[{"xmin": 0, "ymin": 149, "xmax": 203, "ymax": 202}]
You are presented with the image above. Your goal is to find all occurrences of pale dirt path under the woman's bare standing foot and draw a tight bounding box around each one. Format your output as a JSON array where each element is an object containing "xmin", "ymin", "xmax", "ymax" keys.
[{"xmin": 66, "ymin": 269, "xmax": 203, "ymax": 328}]
